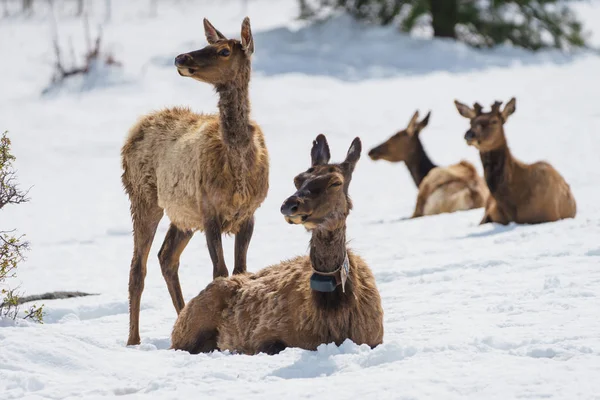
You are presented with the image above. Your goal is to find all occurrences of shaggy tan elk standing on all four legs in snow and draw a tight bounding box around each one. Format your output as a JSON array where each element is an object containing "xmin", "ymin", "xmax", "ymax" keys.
[{"xmin": 121, "ymin": 18, "xmax": 269, "ymax": 345}]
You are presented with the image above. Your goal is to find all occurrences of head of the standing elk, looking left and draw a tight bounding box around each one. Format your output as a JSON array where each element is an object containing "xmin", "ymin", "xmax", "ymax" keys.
[{"xmin": 175, "ymin": 17, "xmax": 254, "ymax": 86}]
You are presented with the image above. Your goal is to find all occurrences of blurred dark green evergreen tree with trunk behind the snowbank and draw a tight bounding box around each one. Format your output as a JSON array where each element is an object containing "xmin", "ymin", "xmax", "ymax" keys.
[{"xmin": 299, "ymin": 0, "xmax": 585, "ymax": 50}]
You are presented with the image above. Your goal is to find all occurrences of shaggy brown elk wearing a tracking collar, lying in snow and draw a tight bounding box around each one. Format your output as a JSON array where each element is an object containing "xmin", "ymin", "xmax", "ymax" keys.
[{"xmin": 171, "ymin": 135, "xmax": 383, "ymax": 354}]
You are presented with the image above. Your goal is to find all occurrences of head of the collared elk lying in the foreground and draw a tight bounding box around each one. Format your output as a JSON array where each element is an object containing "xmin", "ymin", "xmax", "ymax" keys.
[{"xmin": 281, "ymin": 135, "xmax": 362, "ymax": 230}]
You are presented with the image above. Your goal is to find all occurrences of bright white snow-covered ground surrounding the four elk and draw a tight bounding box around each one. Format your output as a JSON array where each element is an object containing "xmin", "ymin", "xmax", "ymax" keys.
[{"xmin": 0, "ymin": 0, "xmax": 600, "ymax": 399}]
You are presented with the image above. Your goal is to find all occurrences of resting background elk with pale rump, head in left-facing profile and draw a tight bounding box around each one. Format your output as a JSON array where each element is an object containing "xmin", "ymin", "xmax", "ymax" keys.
[{"xmin": 369, "ymin": 111, "xmax": 489, "ymax": 218}]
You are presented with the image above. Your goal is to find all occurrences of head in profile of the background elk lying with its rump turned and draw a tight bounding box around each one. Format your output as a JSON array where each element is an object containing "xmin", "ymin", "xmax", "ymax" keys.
[{"xmin": 369, "ymin": 111, "xmax": 431, "ymax": 162}]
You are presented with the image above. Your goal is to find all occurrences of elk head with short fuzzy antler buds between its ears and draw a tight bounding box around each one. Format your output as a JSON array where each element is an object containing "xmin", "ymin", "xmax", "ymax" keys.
[{"xmin": 454, "ymin": 97, "xmax": 517, "ymax": 152}]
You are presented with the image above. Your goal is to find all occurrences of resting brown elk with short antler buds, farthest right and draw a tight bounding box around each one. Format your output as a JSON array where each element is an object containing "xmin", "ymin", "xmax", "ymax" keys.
[{"xmin": 455, "ymin": 98, "xmax": 577, "ymax": 225}]
